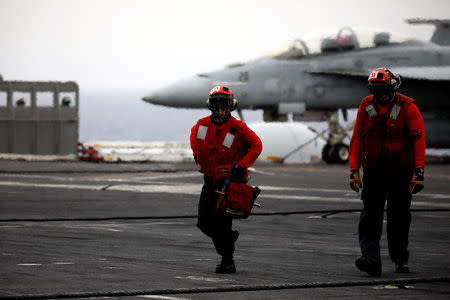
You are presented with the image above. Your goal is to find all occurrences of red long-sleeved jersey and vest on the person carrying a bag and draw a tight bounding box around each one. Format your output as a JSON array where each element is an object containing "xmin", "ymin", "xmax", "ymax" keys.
[{"xmin": 190, "ymin": 116, "xmax": 262, "ymax": 185}]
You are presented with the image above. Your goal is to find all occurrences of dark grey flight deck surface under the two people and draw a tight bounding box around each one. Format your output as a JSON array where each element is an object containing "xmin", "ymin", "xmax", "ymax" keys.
[{"xmin": 0, "ymin": 161, "xmax": 450, "ymax": 299}]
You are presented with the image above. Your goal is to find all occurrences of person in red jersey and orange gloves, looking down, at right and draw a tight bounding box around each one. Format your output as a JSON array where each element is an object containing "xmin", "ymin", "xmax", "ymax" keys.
[{"xmin": 349, "ymin": 68, "xmax": 425, "ymax": 276}]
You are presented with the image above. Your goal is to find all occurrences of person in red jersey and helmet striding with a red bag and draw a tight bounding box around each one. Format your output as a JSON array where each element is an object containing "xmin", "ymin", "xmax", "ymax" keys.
[{"xmin": 190, "ymin": 86, "xmax": 262, "ymax": 273}]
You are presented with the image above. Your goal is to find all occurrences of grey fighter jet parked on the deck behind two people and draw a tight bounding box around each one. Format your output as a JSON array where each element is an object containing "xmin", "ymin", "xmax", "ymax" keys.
[{"xmin": 143, "ymin": 18, "xmax": 450, "ymax": 163}]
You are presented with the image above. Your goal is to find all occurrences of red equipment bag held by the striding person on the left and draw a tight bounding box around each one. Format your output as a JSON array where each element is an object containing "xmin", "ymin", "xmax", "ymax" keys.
[{"xmin": 216, "ymin": 180, "xmax": 261, "ymax": 219}]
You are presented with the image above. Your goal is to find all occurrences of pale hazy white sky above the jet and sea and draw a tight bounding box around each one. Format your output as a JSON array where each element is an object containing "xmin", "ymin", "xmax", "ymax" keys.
[{"xmin": 0, "ymin": 0, "xmax": 450, "ymax": 91}]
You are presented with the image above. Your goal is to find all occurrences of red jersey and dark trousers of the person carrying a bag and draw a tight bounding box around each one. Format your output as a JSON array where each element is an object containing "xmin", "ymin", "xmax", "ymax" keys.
[{"xmin": 190, "ymin": 116, "xmax": 262, "ymax": 261}]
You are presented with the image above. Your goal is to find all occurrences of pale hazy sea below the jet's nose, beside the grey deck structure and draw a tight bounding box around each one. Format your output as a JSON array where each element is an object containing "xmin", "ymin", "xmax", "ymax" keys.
[{"xmin": 79, "ymin": 91, "xmax": 262, "ymax": 142}]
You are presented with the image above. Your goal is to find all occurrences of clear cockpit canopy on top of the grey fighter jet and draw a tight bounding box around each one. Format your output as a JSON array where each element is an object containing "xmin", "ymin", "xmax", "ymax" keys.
[{"xmin": 266, "ymin": 27, "xmax": 424, "ymax": 59}]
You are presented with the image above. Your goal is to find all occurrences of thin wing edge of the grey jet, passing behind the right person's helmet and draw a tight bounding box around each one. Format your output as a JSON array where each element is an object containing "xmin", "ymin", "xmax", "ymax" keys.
[{"xmin": 308, "ymin": 66, "xmax": 450, "ymax": 81}]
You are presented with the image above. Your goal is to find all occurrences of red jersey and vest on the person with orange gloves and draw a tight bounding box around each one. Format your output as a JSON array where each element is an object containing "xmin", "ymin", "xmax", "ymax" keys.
[{"xmin": 349, "ymin": 92, "xmax": 425, "ymax": 170}]
